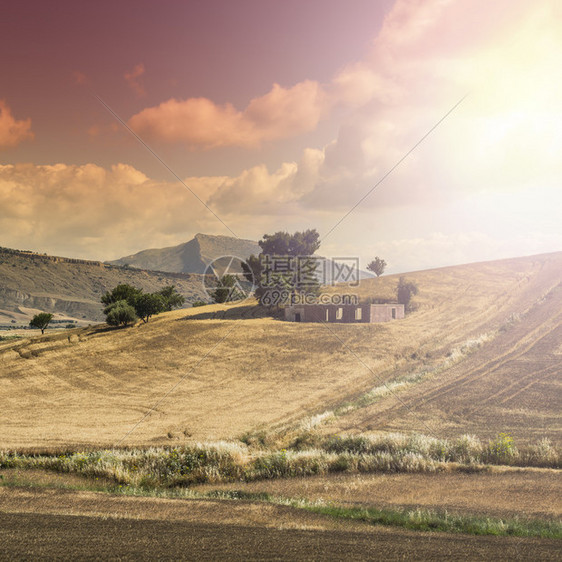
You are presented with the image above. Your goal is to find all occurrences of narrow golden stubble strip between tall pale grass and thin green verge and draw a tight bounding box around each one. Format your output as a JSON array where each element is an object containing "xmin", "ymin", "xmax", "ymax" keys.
[{"xmin": 193, "ymin": 469, "xmax": 562, "ymax": 519}]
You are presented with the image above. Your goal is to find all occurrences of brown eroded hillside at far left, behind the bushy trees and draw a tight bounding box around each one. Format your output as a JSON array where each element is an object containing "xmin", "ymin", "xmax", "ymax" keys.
[{"xmin": 0, "ymin": 248, "xmax": 205, "ymax": 326}]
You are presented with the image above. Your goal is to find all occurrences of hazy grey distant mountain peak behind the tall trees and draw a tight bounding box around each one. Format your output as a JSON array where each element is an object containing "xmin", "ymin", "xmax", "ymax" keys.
[{"xmin": 107, "ymin": 234, "xmax": 261, "ymax": 273}]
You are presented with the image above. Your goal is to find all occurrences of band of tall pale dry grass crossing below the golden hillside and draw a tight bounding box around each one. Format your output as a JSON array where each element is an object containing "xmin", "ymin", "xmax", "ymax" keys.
[{"xmin": 0, "ymin": 434, "xmax": 561, "ymax": 489}]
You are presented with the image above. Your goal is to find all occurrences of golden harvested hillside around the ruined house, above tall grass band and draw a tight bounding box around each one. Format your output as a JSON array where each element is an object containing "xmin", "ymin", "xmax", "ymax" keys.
[{"xmin": 0, "ymin": 248, "xmax": 562, "ymax": 447}]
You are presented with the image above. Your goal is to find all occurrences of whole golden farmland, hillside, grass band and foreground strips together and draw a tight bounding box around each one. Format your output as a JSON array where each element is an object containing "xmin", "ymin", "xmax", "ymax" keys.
[{"xmin": 0, "ymin": 253, "xmax": 562, "ymax": 559}]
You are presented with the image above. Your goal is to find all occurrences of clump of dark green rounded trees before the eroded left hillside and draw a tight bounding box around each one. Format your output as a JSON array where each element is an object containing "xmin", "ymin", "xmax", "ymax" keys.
[{"xmin": 101, "ymin": 283, "xmax": 185, "ymax": 326}]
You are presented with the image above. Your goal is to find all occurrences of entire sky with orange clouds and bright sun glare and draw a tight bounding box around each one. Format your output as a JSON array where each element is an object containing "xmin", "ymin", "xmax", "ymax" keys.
[{"xmin": 0, "ymin": 0, "xmax": 562, "ymax": 272}]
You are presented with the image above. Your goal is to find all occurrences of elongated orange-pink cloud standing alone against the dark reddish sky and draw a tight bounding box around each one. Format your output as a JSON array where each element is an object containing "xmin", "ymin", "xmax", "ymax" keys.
[{"xmin": 129, "ymin": 80, "xmax": 328, "ymax": 149}]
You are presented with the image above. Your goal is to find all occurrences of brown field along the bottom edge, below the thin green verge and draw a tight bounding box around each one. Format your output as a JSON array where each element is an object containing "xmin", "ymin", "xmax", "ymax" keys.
[{"xmin": 0, "ymin": 490, "xmax": 559, "ymax": 560}]
